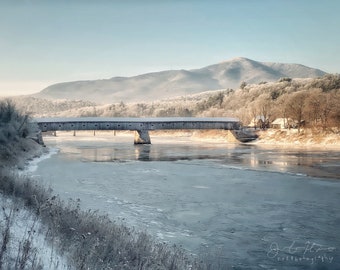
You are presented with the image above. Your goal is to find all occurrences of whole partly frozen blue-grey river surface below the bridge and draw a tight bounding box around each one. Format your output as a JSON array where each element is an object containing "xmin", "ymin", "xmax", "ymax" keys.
[{"xmin": 32, "ymin": 134, "xmax": 340, "ymax": 269}]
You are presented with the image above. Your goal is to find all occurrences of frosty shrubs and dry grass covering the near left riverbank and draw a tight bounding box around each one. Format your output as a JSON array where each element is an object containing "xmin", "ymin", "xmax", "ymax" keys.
[{"xmin": 0, "ymin": 102, "xmax": 222, "ymax": 270}]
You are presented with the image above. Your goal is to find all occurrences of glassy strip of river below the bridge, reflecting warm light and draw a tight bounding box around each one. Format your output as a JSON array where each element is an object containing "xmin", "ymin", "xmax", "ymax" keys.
[{"xmin": 43, "ymin": 138, "xmax": 340, "ymax": 178}]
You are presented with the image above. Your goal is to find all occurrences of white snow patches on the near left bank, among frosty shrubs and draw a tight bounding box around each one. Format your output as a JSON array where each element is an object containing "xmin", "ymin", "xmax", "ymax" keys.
[{"xmin": 0, "ymin": 143, "xmax": 71, "ymax": 270}]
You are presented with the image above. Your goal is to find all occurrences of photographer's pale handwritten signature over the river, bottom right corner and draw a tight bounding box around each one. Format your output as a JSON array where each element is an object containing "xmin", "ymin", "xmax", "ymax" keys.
[{"xmin": 267, "ymin": 241, "xmax": 336, "ymax": 264}]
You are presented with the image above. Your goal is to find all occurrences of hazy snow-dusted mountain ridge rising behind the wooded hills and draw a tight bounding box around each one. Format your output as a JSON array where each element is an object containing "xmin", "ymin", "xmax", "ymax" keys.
[{"xmin": 34, "ymin": 58, "xmax": 326, "ymax": 103}]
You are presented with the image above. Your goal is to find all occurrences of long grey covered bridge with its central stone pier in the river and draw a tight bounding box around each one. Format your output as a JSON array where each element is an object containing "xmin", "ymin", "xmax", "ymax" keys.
[{"xmin": 34, "ymin": 117, "xmax": 251, "ymax": 144}]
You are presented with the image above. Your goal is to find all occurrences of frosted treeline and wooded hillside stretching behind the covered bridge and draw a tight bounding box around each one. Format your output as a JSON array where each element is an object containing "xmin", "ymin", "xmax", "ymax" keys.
[{"xmin": 7, "ymin": 74, "xmax": 340, "ymax": 129}]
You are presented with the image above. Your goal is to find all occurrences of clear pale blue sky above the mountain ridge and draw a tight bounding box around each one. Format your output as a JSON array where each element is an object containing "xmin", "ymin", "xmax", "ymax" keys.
[{"xmin": 0, "ymin": 0, "xmax": 340, "ymax": 96}]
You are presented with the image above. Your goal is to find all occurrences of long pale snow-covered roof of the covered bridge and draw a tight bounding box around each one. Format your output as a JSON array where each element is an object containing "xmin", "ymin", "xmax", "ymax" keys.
[{"xmin": 33, "ymin": 117, "xmax": 240, "ymax": 123}]
